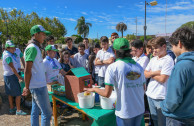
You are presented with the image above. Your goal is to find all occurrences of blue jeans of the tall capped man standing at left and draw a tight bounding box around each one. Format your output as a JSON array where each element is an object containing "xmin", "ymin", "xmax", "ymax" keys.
[{"xmin": 30, "ymin": 86, "xmax": 52, "ymax": 126}]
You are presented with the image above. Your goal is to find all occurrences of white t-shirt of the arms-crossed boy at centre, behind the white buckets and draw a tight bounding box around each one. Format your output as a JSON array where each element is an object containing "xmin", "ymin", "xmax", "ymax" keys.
[{"xmin": 96, "ymin": 49, "xmax": 115, "ymax": 77}]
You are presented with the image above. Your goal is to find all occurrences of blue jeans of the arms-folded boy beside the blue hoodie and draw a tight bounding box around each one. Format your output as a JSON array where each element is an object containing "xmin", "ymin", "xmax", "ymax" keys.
[{"xmin": 147, "ymin": 97, "xmax": 166, "ymax": 126}]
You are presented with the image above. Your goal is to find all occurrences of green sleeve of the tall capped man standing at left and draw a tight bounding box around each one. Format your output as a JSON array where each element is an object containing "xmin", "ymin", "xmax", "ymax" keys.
[{"xmin": 25, "ymin": 47, "xmax": 37, "ymax": 61}]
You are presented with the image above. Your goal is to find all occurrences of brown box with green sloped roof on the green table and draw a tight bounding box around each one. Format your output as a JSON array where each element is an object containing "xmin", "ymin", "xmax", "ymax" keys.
[{"xmin": 65, "ymin": 67, "xmax": 93, "ymax": 103}]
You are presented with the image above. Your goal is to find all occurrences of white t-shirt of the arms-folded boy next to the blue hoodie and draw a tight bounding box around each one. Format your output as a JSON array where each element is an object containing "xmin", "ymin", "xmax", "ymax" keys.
[{"xmin": 145, "ymin": 55, "xmax": 174, "ymax": 99}]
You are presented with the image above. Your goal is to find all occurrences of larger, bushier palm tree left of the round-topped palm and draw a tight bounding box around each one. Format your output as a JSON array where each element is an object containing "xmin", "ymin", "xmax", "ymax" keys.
[{"xmin": 75, "ymin": 16, "xmax": 92, "ymax": 38}]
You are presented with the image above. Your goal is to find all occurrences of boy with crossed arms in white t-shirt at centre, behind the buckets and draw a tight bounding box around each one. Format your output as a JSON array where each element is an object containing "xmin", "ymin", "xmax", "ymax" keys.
[{"xmin": 94, "ymin": 36, "xmax": 115, "ymax": 87}]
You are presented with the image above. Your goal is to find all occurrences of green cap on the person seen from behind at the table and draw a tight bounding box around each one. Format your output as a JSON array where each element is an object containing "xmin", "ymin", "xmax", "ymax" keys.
[{"xmin": 113, "ymin": 38, "xmax": 129, "ymax": 50}]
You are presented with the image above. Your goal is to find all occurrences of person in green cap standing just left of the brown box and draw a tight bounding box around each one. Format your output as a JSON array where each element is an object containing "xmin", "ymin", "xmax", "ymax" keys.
[{"xmin": 43, "ymin": 45, "xmax": 65, "ymax": 84}]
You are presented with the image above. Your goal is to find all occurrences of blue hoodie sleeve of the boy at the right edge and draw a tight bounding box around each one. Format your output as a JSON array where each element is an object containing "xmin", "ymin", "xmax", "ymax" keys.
[{"xmin": 160, "ymin": 66, "xmax": 185, "ymax": 113}]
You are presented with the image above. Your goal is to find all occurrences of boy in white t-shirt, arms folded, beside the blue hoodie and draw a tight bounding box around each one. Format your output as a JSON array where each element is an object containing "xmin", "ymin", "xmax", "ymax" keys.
[{"xmin": 144, "ymin": 37, "xmax": 174, "ymax": 126}]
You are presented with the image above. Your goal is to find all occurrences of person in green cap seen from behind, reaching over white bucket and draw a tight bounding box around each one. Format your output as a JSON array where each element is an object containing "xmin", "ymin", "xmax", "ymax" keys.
[{"xmin": 84, "ymin": 38, "xmax": 146, "ymax": 126}]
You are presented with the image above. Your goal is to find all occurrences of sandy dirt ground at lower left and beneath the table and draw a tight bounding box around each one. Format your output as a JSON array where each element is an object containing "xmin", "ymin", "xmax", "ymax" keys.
[{"xmin": 0, "ymin": 60, "xmax": 92, "ymax": 126}]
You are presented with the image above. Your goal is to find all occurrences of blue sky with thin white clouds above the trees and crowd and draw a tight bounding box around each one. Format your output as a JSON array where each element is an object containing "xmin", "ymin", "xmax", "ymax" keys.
[{"xmin": 0, "ymin": 0, "xmax": 194, "ymax": 38}]
